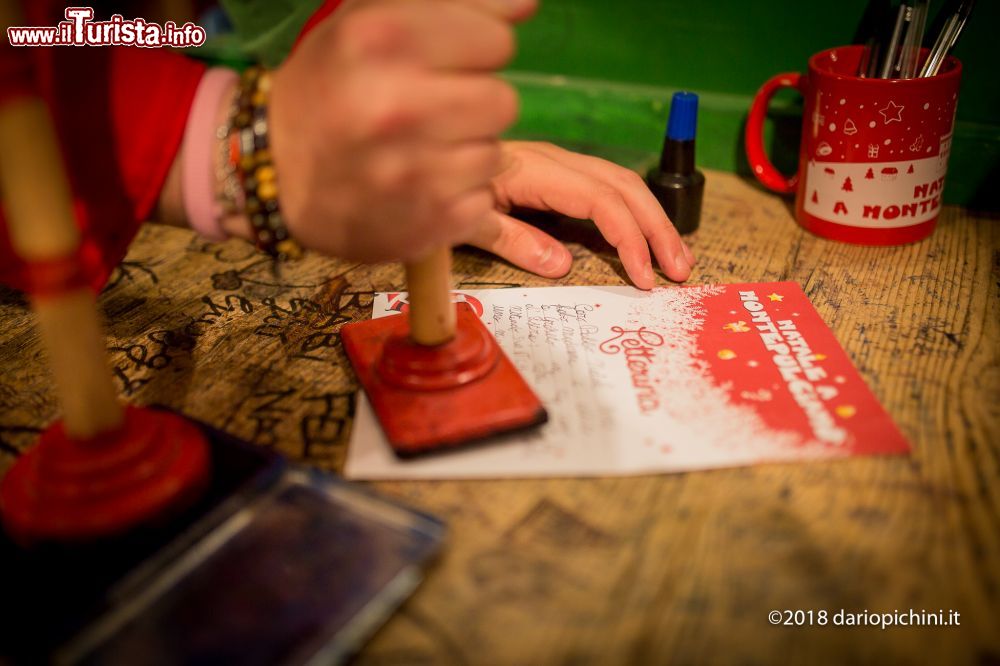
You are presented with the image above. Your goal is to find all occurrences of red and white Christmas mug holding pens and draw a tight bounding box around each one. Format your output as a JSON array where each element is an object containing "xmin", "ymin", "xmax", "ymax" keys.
[{"xmin": 746, "ymin": 46, "xmax": 962, "ymax": 245}]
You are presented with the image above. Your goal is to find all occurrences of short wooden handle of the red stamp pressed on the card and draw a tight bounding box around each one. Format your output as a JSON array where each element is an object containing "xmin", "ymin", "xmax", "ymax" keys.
[{"xmin": 406, "ymin": 247, "xmax": 455, "ymax": 346}]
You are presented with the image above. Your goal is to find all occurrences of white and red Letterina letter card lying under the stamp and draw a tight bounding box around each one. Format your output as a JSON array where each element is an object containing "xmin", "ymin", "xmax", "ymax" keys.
[{"xmin": 345, "ymin": 282, "xmax": 909, "ymax": 478}]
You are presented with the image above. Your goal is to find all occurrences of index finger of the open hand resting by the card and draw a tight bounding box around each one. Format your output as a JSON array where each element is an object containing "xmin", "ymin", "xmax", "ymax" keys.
[{"xmin": 494, "ymin": 151, "xmax": 655, "ymax": 289}]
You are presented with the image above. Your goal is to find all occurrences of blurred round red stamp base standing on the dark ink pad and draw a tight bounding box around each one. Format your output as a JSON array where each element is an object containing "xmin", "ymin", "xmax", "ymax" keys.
[{"xmin": 0, "ymin": 406, "xmax": 210, "ymax": 544}]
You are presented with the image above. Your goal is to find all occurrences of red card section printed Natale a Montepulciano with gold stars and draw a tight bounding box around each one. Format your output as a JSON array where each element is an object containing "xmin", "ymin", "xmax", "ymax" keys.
[{"xmin": 698, "ymin": 282, "xmax": 909, "ymax": 455}]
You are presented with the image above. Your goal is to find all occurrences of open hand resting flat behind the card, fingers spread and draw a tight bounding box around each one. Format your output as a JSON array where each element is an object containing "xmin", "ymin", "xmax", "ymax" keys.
[{"xmin": 472, "ymin": 142, "xmax": 695, "ymax": 289}]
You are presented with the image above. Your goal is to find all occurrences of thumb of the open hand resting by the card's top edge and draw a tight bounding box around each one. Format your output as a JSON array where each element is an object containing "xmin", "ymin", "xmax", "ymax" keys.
[{"xmin": 468, "ymin": 211, "xmax": 573, "ymax": 278}]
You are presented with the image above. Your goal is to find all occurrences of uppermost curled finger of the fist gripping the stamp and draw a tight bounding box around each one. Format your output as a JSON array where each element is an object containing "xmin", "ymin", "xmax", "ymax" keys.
[{"xmin": 340, "ymin": 0, "xmax": 514, "ymax": 71}]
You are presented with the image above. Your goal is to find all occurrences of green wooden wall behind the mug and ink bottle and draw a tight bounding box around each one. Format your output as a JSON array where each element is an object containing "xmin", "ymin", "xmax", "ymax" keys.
[{"xmin": 506, "ymin": 0, "xmax": 1000, "ymax": 210}]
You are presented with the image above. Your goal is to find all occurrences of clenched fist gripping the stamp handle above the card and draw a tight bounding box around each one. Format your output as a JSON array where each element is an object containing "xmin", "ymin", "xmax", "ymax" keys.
[{"xmin": 269, "ymin": 0, "xmax": 534, "ymax": 261}]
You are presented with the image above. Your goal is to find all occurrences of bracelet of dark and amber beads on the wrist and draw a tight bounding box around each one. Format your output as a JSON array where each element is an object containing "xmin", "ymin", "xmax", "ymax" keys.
[{"xmin": 229, "ymin": 67, "xmax": 302, "ymax": 259}]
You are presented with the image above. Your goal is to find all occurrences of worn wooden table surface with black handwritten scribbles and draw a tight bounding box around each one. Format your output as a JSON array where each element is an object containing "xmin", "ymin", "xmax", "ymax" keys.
[{"xmin": 0, "ymin": 173, "xmax": 1000, "ymax": 664}]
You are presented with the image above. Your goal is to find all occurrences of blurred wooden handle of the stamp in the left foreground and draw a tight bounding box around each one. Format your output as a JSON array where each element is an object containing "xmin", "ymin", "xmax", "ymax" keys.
[{"xmin": 0, "ymin": 97, "xmax": 123, "ymax": 439}]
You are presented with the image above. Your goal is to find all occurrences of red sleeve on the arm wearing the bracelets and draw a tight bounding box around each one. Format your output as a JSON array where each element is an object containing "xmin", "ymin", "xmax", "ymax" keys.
[{"xmin": 0, "ymin": 0, "xmax": 339, "ymax": 289}]
